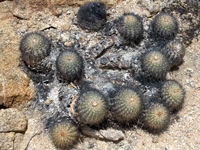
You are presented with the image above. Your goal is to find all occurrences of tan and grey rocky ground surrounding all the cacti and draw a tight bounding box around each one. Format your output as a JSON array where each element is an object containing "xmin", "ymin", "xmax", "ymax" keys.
[{"xmin": 0, "ymin": 0, "xmax": 200, "ymax": 150}]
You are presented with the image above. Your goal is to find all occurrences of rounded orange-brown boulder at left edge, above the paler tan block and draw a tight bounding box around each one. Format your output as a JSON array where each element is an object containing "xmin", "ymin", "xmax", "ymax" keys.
[{"xmin": 0, "ymin": 67, "xmax": 33, "ymax": 107}]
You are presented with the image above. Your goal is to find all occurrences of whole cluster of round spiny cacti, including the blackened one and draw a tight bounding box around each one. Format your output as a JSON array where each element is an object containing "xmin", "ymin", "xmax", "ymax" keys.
[{"xmin": 20, "ymin": 2, "xmax": 188, "ymax": 149}]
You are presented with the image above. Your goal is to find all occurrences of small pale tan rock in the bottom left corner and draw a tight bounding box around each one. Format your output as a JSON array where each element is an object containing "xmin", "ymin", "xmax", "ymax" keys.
[{"xmin": 0, "ymin": 132, "xmax": 15, "ymax": 150}]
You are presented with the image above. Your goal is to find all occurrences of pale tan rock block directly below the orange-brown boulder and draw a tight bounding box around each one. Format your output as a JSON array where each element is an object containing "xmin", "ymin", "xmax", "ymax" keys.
[{"xmin": 0, "ymin": 108, "xmax": 27, "ymax": 132}]
